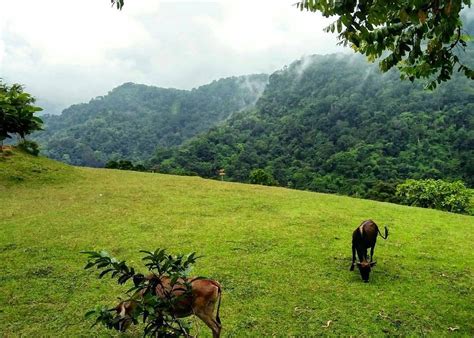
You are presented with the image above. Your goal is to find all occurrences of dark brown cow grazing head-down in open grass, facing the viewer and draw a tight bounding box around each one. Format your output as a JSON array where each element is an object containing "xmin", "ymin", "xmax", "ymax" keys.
[{"xmin": 350, "ymin": 219, "xmax": 388, "ymax": 283}]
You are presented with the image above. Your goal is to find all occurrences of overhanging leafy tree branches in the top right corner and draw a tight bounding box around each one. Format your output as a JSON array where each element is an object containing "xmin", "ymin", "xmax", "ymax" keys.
[{"xmin": 296, "ymin": 0, "xmax": 474, "ymax": 89}]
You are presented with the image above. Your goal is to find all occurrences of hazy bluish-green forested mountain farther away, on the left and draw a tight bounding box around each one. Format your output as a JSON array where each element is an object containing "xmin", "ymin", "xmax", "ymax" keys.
[{"xmin": 35, "ymin": 74, "xmax": 268, "ymax": 166}]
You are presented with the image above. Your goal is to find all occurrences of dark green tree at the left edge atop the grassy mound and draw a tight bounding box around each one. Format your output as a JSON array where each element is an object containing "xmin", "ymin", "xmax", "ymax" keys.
[{"xmin": 0, "ymin": 82, "xmax": 43, "ymax": 149}]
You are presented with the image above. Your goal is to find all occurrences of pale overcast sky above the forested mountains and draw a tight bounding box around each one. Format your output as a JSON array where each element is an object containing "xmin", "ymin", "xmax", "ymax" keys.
[{"xmin": 0, "ymin": 0, "xmax": 343, "ymax": 113}]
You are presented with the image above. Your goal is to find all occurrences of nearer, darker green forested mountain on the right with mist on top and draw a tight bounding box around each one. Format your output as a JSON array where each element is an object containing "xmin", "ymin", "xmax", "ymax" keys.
[{"xmin": 150, "ymin": 55, "xmax": 474, "ymax": 200}]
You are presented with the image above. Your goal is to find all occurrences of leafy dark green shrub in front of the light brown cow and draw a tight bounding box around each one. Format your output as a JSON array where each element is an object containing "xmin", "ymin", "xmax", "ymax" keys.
[{"xmin": 82, "ymin": 248, "xmax": 198, "ymax": 337}]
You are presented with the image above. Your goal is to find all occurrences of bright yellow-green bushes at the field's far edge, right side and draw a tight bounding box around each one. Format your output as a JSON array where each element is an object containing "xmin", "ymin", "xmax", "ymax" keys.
[{"xmin": 396, "ymin": 179, "xmax": 471, "ymax": 213}]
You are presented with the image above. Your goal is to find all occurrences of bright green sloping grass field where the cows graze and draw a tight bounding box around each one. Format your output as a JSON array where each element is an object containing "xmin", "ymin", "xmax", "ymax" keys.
[{"xmin": 0, "ymin": 152, "xmax": 474, "ymax": 336}]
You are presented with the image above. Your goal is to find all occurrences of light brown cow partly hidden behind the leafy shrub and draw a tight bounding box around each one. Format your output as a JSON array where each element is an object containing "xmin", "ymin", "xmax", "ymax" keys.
[{"xmin": 115, "ymin": 275, "xmax": 222, "ymax": 338}]
